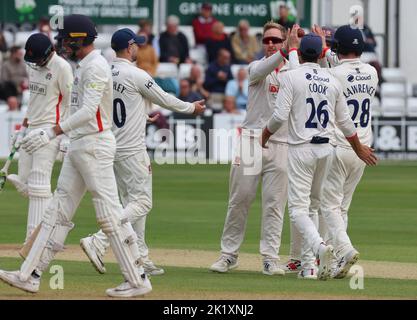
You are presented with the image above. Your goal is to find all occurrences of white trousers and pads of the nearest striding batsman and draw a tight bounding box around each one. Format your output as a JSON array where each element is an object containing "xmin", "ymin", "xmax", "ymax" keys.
[{"xmin": 21, "ymin": 130, "xmax": 143, "ymax": 286}]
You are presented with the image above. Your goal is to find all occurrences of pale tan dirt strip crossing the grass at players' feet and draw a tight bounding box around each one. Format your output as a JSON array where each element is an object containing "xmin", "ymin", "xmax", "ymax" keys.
[{"xmin": 0, "ymin": 244, "xmax": 417, "ymax": 280}]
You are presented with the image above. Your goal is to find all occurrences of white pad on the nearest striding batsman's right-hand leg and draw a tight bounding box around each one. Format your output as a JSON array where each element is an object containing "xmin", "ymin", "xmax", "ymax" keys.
[{"xmin": 93, "ymin": 199, "xmax": 143, "ymax": 287}]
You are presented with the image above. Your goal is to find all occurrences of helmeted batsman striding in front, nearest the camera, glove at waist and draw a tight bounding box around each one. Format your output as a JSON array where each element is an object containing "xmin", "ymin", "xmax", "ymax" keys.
[{"xmin": 0, "ymin": 14, "xmax": 152, "ymax": 297}]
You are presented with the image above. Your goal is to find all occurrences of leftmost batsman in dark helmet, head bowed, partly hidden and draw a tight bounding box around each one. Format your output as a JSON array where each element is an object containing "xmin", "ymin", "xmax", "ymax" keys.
[{"xmin": 7, "ymin": 33, "xmax": 73, "ymax": 243}]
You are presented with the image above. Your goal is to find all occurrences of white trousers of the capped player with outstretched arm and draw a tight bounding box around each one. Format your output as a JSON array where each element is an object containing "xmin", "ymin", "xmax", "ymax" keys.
[{"xmin": 93, "ymin": 151, "xmax": 152, "ymax": 260}]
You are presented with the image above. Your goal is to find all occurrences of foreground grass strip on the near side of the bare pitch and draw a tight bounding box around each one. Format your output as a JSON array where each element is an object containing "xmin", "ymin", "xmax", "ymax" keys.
[{"xmin": 0, "ymin": 258, "xmax": 417, "ymax": 300}]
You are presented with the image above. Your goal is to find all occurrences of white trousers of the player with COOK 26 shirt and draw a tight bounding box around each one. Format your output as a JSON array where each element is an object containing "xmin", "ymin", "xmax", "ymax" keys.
[{"xmin": 288, "ymin": 143, "xmax": 334, "ymax": 269}]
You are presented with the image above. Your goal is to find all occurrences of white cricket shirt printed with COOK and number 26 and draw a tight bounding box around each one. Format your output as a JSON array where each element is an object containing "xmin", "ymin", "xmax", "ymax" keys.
[{"xmin": 267, "ymin": 63, "xmax": 356, "ymax": 145}]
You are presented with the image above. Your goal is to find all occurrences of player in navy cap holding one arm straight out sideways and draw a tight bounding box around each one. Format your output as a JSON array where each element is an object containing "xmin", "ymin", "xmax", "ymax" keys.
[{"xmin": 81, "ymin": 28, "xmax": 205, "ymax": 275}]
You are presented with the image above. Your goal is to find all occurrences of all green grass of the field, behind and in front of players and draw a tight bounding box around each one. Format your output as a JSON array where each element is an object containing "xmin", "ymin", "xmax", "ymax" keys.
[{"xmin": 0, "ymin": 162, "xmax": 417, "ymax": 299}]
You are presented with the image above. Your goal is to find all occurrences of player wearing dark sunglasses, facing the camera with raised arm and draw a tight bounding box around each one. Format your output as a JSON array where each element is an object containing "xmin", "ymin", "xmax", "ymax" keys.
[{"xmin": 210, "ymin": 22, "xmax": 297, "ymax": 275}]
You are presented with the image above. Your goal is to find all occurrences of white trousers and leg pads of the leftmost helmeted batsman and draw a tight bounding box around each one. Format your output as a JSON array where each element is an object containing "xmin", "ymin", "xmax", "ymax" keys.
[{"xmin": 18, "ymin": 134, "xmax": 61, "ymax": 242}]
